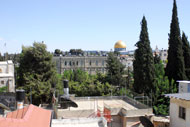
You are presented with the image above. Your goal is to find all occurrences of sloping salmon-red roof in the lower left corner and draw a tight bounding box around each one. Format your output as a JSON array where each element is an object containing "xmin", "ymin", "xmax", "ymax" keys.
[{"xmin": 0, "ymin": 105, "xmax": 51, "ymax": 127}]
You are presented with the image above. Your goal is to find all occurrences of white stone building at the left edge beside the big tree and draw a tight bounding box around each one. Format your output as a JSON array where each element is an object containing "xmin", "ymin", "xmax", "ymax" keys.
[{"xmin": 0, "ymin": 60, "xmax": 15, "ymax": 92}]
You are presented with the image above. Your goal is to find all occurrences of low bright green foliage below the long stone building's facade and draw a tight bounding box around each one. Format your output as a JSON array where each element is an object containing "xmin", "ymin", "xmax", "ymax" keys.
[{"xmin": 63, "ymin": 70, "xmax": 114, "ymax": 96}]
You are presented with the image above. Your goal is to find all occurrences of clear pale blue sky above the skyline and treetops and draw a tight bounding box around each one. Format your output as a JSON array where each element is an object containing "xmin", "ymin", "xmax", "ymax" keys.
[{"xmin": 0, "ymin": 0, "xmax": 190, "ymax": 53}]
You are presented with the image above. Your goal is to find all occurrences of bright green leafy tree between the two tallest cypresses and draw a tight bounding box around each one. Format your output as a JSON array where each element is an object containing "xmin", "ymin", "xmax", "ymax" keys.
[{"xmin": 152, "ymin": 61, "xmax": 176, "ymax": 115}]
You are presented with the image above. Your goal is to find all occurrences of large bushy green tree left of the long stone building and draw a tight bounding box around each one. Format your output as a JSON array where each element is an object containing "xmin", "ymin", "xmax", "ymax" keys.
[{"xmin": 18, "ymin": 42, "xmax": 56, "ymax": 105}]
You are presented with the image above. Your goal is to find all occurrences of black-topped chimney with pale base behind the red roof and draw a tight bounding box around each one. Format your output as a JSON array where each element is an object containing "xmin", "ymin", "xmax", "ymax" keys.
[{"xmin": 16, "ymin": 90, "xmax": 25, "ymax": 109}]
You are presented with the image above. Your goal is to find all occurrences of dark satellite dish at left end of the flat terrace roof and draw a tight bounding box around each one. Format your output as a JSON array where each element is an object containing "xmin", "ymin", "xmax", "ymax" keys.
[{"xmin": 60, "ymin": 96, "xmax": 78, "ymax": 109}]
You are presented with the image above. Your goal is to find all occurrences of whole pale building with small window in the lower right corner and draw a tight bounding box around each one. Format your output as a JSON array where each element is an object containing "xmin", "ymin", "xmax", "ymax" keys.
[{"xmin": 165, "ymin": 81, "xmax": 190, "ymax": 127}]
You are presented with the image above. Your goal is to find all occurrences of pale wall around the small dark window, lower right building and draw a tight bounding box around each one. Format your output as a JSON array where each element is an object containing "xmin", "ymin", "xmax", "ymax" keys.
[{"xmin": 170, "ymin": 99, "xmax": 190, "ymax": 127}]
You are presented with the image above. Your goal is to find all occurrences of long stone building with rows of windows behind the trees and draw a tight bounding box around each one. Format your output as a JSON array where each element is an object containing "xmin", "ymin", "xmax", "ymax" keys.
[{"xmin": 53, "ymin": 56, "xmax": 107, "ymax": 74}]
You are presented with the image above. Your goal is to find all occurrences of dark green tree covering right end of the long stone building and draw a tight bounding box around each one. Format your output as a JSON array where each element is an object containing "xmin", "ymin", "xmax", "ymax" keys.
[{"xmin": 106, "ymin": 52, "xmax": 125, "ymax": 87}]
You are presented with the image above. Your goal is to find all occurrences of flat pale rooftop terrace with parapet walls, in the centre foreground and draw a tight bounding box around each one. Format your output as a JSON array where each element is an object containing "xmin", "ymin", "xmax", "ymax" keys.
[{"xmin": 58, "ymin": 97, "xmax": 152, "ymax": 118}]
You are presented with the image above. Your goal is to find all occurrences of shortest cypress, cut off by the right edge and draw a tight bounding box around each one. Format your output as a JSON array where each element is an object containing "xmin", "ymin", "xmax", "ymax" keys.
[{"xmin": 182, "ymin": 32, "xmax": 190, "ymax": 80}]
